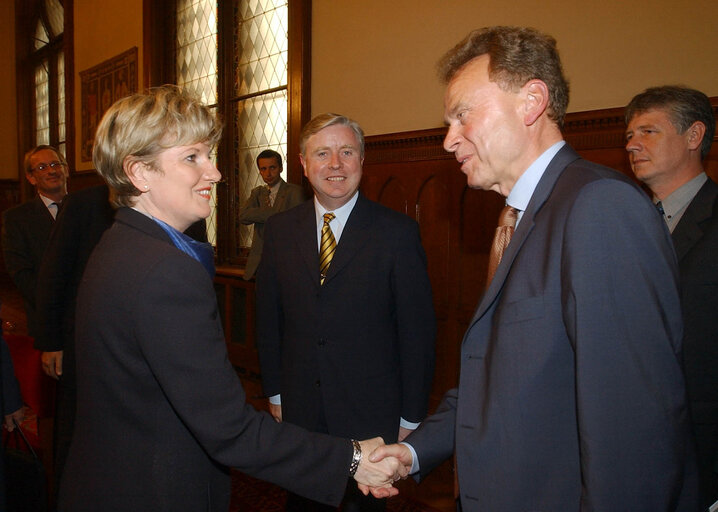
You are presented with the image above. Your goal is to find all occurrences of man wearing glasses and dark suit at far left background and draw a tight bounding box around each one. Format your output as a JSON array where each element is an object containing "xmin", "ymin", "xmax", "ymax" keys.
[{"xmin": 2, "ymin": 145, "xmax": 68, "ymax": 337}]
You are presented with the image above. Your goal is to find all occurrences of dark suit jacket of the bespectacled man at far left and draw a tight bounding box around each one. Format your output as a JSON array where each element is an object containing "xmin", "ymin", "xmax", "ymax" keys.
[{"xmin": 2, "ymin": 196, "xmax": 54, "ymax": 337}]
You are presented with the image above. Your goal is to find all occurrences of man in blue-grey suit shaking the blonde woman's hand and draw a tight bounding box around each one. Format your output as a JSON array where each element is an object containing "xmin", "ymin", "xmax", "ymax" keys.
[{"xmin": 371, "ymin": 27, "xmax": 697, "ymax": 512}]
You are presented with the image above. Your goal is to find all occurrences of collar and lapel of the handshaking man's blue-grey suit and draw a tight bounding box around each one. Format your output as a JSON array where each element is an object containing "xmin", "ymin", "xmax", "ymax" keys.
[{"xmin": 467, "ymin": 144, "xmax": 580, "ymax": 326}]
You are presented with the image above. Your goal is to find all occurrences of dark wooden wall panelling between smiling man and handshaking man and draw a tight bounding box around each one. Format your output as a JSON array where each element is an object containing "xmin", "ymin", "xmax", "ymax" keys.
[{"xmin": 361, "ymin": 128, "xmax": 510, "ymax": 406}]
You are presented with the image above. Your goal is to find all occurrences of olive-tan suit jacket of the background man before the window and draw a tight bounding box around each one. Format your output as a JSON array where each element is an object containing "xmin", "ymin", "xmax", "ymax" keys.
[{"xmin": 239, "ymin": 180, "xmax": 304, "ymax": 280}]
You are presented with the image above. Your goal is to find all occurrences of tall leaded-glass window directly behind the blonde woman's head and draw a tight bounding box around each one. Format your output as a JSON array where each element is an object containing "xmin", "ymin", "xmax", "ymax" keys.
[{"xmin": 176, "ymin": 0, "xmax": 289, "ymax": 252}]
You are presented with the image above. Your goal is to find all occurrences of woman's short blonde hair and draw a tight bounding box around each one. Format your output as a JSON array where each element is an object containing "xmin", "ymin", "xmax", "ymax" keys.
[{"xmin": 92, "ymin": 85, "xmax": 222, "ymax": 206}]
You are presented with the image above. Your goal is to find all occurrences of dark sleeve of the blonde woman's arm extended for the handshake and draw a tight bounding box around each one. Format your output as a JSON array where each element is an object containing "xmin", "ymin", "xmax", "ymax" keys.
[{"xmin": 135, "ymin": 254, "xmax": 352, "ymax": 505}]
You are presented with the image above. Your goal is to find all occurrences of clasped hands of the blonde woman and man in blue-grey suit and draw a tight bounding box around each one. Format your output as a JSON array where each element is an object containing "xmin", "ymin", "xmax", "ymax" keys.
[{"xmin": 354, "ymin": 437, "xmax": 413, "ymax": 498}]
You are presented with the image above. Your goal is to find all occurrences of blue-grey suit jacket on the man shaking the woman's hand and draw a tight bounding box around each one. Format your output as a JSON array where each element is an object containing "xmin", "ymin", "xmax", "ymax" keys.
[{"xmin": 407, "ymin": 146, "xmax": 697, "ymax": 512}]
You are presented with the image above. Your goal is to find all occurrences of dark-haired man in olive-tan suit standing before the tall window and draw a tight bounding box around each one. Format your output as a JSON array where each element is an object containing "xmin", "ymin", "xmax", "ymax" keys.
[{"xmin": 239, "ymin": 149, "xmax": 304, "ymax": 280}]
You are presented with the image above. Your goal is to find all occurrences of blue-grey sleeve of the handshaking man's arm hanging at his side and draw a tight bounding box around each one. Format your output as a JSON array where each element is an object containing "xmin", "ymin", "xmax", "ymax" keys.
[{"xmin": 561, "ymin": 180, "xmax": 690, "ymax": 510}]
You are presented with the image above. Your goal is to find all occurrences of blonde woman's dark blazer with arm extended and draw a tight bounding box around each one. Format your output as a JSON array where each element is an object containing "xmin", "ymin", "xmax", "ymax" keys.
[{"xmin": 59, "ymin": 208, "xmax": 352, "ymax": 512}]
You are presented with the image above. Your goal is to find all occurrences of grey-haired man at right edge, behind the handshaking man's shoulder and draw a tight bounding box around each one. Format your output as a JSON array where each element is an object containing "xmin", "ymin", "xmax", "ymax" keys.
[{"xmin": 626, "ymin": 86, "xmax": 718, "ymax": 510}]
